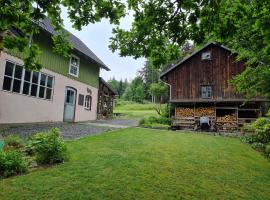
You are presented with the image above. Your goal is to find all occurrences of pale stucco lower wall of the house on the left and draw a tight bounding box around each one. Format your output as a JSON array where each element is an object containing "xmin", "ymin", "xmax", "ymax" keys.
[{"xmin": 0, "ymin": 51, "xmax": 98, "ymax": 124}]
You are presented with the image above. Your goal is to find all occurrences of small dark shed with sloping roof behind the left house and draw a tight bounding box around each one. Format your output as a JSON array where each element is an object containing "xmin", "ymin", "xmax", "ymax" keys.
[{"xmin": 97, "ymin": 77, "xmax": 116, "ymax": 119}]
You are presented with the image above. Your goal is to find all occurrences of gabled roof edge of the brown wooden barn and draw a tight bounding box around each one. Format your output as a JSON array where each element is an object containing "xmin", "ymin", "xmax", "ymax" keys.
[{"xmin": 160, "ymin": 42, "xmax": 231, "ymax": 78}]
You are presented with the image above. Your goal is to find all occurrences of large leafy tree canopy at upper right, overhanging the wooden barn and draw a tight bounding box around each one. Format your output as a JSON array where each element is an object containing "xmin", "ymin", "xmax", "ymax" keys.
[{"xmin": 110, "ymin": 0, "xmax": 270, "ymax": 98}]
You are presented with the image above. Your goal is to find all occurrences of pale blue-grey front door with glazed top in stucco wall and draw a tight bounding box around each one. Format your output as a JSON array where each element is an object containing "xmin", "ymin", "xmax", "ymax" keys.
[{"xmin": 64, "ymin": 87, "xmax": 76, "ymax": 122}]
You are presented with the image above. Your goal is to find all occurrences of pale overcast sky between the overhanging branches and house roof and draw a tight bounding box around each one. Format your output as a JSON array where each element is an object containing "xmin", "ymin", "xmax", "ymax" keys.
[{"xmin": 62, "ymin": 9, "xmax": 145, "ymax": 80}]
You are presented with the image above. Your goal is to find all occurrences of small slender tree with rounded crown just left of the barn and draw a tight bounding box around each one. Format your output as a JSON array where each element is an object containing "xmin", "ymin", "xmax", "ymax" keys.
[{"xmin": 150, "ymin": 83, "xmax": 168, "ymax": 115}]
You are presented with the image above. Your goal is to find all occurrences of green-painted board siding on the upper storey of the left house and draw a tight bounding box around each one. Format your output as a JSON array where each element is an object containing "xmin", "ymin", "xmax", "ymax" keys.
[{"xmin": 6, "ymin": 31, "xmax": 100, "ymax": 88}]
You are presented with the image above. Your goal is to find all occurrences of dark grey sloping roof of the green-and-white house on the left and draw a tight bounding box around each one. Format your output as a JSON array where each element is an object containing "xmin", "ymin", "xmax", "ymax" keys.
[{"xmin": 38, "ymin": 18, "xmax": 110, "ymax": 71}]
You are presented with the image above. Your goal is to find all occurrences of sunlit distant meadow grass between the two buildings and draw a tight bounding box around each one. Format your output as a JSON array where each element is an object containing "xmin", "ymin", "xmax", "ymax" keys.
[{"xmin": 114, "ymin": 101, "xmax": 165, "ymax": 120}]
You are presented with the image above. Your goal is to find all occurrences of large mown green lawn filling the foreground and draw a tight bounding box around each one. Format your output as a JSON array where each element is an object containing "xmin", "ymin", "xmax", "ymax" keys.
[{"xmin": 0, "ymin": 128, "xmax": 270, "ymax": 200}]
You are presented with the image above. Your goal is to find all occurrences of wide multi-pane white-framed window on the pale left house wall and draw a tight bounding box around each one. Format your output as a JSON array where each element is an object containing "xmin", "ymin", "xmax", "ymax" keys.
[{"xmin": 3, "ymin": 61, "xmax": 53, "ymax": 100}]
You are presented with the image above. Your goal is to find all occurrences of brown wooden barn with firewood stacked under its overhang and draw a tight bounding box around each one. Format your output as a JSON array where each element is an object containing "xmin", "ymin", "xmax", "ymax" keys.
[{"xmin": 160, "ymin": 42, "xmax": 265, "ymax": 130}]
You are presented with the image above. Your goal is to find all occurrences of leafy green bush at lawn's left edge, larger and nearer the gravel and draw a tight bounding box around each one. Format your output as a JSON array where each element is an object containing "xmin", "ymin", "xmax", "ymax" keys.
[{"xmin": 26, "ymin": 128, "xmax": 68, "ymax": 164}]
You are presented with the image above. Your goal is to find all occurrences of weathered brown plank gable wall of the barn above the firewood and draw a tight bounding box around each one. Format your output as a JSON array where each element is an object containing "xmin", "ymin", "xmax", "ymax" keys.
[{"xmin": 166, "ymin": 45, "xmax": 245, "ymax": 101}]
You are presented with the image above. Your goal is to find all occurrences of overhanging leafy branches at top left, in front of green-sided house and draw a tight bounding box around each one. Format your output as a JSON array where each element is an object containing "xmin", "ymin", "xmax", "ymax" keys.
[{"xmin": 0, "ymin": 0, "xmax": 125, "ymax": 70}]
